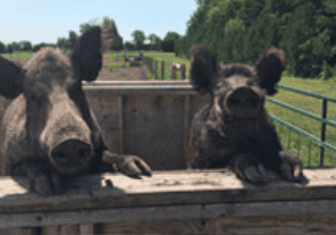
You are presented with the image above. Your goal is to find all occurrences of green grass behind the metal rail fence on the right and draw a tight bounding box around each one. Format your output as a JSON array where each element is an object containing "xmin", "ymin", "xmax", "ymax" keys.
[{"xmin": 265, "ymin": 76, "xmax": 336, "ymax": 167}]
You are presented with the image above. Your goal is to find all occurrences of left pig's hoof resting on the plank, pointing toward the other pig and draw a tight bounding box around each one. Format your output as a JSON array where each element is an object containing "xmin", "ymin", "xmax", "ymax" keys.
[{"xmin": 119, "ymin": 155, "xmax": 152, "ymax": 179}]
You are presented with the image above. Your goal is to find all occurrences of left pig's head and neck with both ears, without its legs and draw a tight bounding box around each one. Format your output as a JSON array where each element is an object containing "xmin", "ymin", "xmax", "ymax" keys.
[{"xmin": 0, "ymin": 27, "xmax": 102, "ymax": 174}]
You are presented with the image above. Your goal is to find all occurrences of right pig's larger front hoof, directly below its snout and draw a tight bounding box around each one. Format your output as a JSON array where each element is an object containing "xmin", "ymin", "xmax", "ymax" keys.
[{"xmin": 232, "ymin": 154, "xmax": 280, "ymax": 184}]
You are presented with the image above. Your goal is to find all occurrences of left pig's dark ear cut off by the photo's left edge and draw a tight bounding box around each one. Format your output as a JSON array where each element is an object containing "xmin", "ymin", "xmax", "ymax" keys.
[{"xmin": 0, "ymin": 56, "xmax": 24, "ymax": 99}]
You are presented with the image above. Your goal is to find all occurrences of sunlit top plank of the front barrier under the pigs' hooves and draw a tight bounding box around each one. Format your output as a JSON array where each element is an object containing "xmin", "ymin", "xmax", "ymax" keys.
[{"xmin": 0, "ymin": 168, "xmax": 336, "ymax": 216}]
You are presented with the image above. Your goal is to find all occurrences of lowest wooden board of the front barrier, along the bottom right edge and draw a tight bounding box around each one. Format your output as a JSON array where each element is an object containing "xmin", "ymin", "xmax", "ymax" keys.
[{"xmin": 101, "ymin": 214, "xmax": 336, "ymax": 235}]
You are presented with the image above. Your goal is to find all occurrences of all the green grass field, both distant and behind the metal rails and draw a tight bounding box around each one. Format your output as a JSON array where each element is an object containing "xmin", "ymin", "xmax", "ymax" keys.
[{"xmin": 5, "ymin": 52, "xmax": 336, "ymax": 167}]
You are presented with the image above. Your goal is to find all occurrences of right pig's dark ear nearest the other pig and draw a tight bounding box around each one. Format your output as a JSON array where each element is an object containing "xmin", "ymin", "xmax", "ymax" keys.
[{"xmin": 189, "ymin": 44, "xmax": 219, "ymax": 93}]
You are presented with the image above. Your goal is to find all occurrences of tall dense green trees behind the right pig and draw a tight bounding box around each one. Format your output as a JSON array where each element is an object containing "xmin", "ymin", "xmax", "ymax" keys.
[{"xmin": 174, "ymin": 0, "xmax": 336, "ymax": 79}]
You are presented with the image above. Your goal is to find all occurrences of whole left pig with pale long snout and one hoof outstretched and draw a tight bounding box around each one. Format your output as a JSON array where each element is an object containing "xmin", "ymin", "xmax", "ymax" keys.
[{"xmin": 0, "ymin": 27, "xmax": 151, "ymax": 195}]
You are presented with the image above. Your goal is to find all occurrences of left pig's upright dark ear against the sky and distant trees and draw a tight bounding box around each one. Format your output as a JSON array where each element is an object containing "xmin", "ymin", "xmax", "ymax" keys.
[{"xmin": 71, "ymin": 27, "xmax": 102, "ymax": 81}]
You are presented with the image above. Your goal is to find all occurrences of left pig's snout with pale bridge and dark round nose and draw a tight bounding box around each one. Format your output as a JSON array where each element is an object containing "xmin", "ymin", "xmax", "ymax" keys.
[{"xmin": 41, "ymin": 105, "xmax": 94, "ymax": 174}]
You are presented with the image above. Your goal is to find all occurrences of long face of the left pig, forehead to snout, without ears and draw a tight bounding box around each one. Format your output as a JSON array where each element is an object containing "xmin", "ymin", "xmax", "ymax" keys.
[{"xmin": 22, "ymin": 48, "xmax": 94, "ymax": 174}]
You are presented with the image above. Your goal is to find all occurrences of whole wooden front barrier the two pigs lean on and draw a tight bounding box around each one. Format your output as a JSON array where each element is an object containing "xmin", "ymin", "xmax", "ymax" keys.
[{"xmin": 0, "ymin": 168, "xmax": 336, "ymax": 235}]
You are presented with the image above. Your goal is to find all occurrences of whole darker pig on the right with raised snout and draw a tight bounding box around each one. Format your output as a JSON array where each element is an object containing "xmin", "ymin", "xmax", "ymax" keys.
[{"xmin": 188, "ymin": 44, "xmax": 304, "ymax": 183}]
